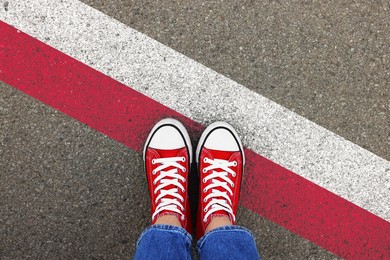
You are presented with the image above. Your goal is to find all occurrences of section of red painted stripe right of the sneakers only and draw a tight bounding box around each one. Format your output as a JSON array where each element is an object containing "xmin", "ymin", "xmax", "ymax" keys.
[{"xmin": 241, "ymin": 150, "xmax": 390, "ymax": 259}]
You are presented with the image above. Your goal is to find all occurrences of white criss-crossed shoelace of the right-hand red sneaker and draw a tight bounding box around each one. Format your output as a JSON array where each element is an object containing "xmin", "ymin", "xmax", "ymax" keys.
[{"xmin": 203, "ymin": 158, "xmax": 237, "ymax": 222}]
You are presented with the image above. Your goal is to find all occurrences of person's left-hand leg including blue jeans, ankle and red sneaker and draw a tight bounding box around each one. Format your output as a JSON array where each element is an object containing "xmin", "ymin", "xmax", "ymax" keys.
[{"xmin": 135, "ymin": 119, "xmax": 192, "ymax": 259}]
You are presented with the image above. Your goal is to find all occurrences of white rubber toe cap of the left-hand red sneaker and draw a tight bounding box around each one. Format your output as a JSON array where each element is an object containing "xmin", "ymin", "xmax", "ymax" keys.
[{"xmin": 149, "ymin": 125, "xmax": 185, "ymax": 150}]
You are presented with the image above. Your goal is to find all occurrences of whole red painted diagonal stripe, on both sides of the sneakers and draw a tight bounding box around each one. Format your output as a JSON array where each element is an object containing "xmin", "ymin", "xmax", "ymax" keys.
[{"xmin": 0, "ymin": 22, "xmax": 390, "ymax": 259}]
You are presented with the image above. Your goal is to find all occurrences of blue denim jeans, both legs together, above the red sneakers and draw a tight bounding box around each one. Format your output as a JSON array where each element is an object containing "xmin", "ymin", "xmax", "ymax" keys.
[{"xmin": 134, "ymin": 225, "xmax": 260, "ymax": 259}]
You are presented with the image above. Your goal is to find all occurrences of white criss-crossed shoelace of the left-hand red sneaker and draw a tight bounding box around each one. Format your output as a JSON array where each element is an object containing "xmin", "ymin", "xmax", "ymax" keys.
[{"xmin": 152, "ymin": 157, "xmax": 186, "ymax": 220}]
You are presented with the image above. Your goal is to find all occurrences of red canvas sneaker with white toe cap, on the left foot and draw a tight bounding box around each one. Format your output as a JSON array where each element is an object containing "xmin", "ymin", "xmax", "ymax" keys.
[{"xmin": 143, "ymin": 118, "xmax": 192, "ymax": 234}]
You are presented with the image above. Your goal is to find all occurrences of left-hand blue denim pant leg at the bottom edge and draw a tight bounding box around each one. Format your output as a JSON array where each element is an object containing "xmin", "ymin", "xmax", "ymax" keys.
[{"xmin": 134, "ymin": 225, "xmax": 192, "ymax": 259}]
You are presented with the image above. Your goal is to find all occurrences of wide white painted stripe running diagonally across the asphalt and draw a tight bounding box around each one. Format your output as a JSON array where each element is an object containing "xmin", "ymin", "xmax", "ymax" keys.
[{"xmin": 0, "ymin": 0, "xmax": 390, "ymax": 221}]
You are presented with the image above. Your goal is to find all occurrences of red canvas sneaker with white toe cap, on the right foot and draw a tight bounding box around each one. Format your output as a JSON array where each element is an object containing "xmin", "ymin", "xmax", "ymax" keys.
[{"xmin": 196, "ymin": 122, "xmax": 245, "ymax": 238}]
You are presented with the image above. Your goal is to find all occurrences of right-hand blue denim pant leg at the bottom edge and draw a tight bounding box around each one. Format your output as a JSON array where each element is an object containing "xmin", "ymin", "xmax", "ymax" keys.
[{"xmin": 197, "ymin": 226, "xmax": 260, "ymax": 260}]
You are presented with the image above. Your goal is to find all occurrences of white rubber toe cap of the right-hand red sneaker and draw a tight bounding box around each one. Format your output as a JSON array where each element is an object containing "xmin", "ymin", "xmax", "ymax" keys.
[{"xmin": 204, "ymin": 128, "xmax": 240, "ymax": 152}]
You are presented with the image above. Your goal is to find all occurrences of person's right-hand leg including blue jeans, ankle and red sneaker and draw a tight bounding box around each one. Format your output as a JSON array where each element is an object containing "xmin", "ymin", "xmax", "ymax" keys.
[{"xmin": 196, "ymin": 122, "xmax": 260, "ymax": 259}]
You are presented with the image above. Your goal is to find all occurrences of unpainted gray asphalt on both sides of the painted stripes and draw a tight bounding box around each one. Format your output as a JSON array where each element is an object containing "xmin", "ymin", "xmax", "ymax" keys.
[{"xmin": 0, "ymin": 0, "xmax": 390, "ymax": 259}]
